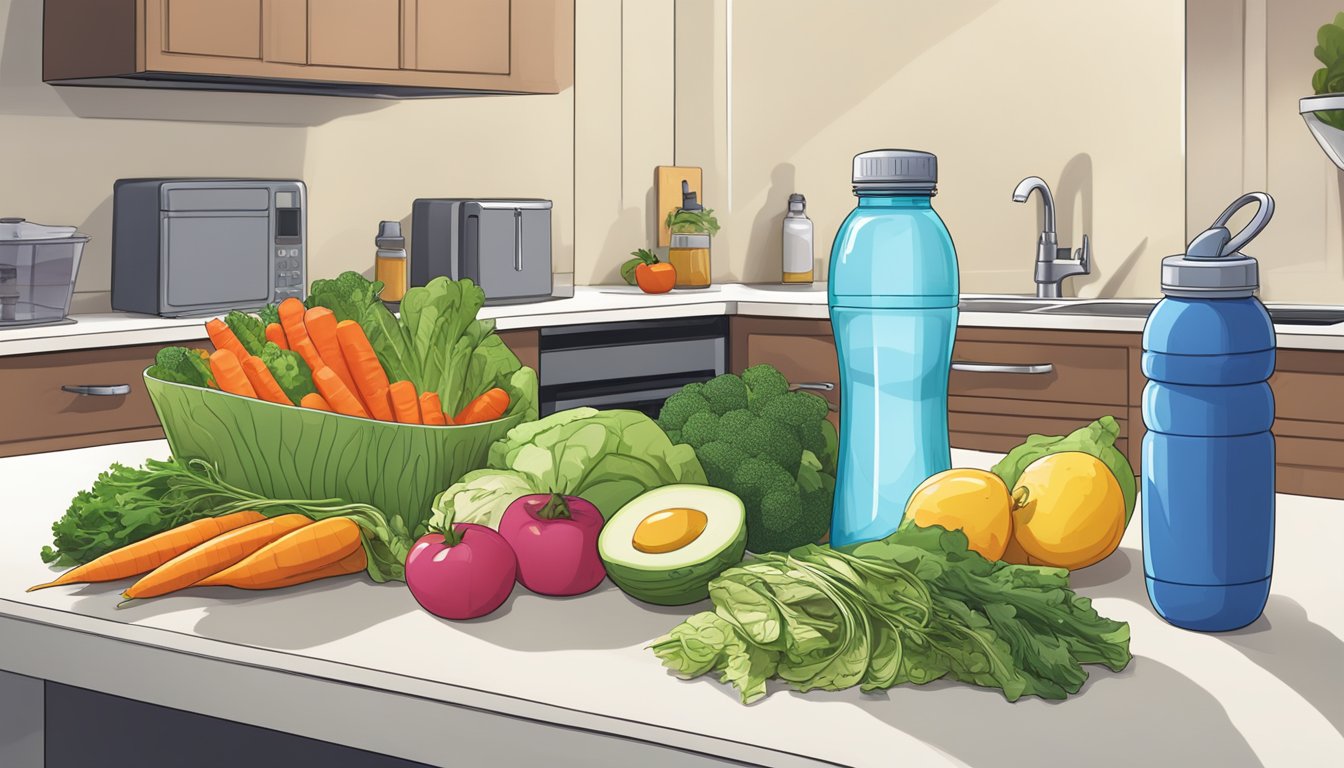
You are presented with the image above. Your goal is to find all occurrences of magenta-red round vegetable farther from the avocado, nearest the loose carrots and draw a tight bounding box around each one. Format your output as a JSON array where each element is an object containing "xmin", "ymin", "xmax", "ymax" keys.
[{"xmin": 406, "ymin": 521, "xmax": 517, "ymax": 619}]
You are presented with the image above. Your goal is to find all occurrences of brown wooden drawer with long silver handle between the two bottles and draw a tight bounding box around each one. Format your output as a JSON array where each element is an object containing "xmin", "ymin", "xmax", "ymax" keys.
[{"xmin": 948, "ymin": 339, "xmax": 1129, "ymax": 409}]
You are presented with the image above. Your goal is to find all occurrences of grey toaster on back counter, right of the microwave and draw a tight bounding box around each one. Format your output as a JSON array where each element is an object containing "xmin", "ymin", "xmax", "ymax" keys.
[{"xmin": 410, "ymin": 198, "xmax": 554, "ymax": 304}]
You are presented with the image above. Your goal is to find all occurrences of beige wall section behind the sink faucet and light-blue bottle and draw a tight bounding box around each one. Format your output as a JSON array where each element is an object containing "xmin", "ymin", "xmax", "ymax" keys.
[{"xmin": 676, "ymin": 0, "xmax": 1184, "ymax": 296}]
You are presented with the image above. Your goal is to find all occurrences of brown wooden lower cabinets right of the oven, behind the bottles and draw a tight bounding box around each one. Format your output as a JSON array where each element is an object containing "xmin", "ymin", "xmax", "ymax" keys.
[{"xmin": 728, "ymin": 316, "xmax": 1344, "ymax": 499}]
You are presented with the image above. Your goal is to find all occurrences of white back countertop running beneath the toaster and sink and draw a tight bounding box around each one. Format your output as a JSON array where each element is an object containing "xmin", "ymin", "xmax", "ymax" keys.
[{"xmin": 0, "ymin": 282, "xmax": 1344, "ymax": 356}]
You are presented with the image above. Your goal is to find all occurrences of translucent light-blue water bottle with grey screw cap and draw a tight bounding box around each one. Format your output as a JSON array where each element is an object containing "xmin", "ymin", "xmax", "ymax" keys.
[{"xmin": 828, "ymin": 149, "xmax": 958, "ymax": 546}]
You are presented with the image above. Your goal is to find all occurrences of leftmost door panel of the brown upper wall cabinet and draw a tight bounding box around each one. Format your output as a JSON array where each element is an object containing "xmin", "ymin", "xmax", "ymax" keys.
[{"xmin": 159, "ymin": 0, "xmax": 261, "ymax": 59}]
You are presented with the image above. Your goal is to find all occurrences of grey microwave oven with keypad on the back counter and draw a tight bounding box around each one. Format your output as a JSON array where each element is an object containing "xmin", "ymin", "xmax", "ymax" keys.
[{"xmin": 112, "ymin": 179, "xmax": 308, "ymax": 317}]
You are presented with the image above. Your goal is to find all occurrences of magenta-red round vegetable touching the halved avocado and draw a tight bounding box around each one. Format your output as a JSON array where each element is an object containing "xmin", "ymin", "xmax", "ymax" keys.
[{"xmin": 500, "ymin": 494, "xmax": 606, "ymax": 596}]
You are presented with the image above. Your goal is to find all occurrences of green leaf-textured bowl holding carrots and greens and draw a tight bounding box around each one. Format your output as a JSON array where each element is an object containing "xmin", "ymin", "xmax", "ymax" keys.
[{"xmin": 145, "ymin": 373, "xmax": 526, "ymax": 535}]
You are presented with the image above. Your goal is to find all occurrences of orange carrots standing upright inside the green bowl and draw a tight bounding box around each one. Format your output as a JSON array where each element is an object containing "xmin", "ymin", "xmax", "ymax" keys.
[{"xmin": 206, "ymin": 299, "xmax": 509, "ymax": 426}]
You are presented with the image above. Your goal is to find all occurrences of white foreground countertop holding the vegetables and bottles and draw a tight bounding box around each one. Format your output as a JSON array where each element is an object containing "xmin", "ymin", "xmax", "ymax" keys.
[{"xmin": 0, "ymin": 441, "xmax": 1344, "ymax": 768}]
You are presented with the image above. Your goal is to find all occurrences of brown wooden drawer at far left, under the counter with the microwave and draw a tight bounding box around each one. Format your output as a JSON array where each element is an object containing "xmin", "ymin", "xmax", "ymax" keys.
[{"xmin": 0, "ymin": 344, "xmax": 169, "ymax": 456}]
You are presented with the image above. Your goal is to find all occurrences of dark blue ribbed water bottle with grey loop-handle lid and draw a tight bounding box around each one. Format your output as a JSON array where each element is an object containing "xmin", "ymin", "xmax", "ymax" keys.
[{"xmin": 1142, "ymin": 192, "xmax": 1275, "ymax": 632}]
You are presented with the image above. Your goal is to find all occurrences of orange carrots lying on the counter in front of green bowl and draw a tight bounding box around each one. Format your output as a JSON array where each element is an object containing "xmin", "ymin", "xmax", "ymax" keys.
[{"xmin": 28, "ymin": 510, "xmax": 368, "ymax": 600}]
